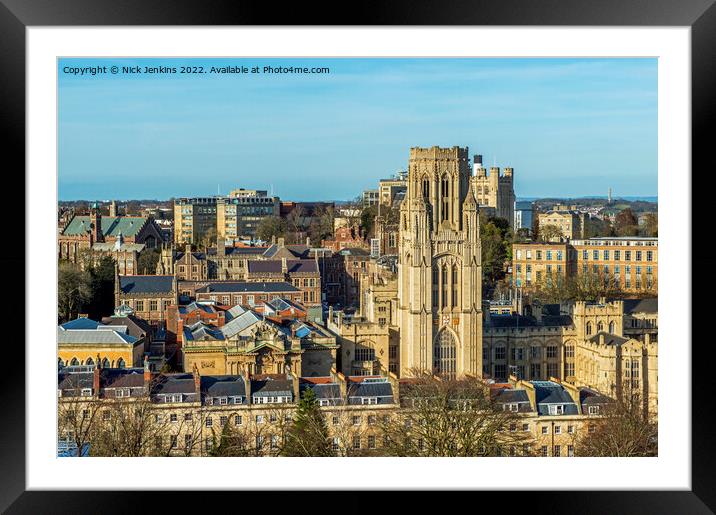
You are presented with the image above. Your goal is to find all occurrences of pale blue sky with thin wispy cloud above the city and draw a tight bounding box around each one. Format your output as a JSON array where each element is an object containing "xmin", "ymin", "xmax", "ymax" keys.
[{"xmin": 58, "ymin": 58, "xmax": 657, "ymax": 201}]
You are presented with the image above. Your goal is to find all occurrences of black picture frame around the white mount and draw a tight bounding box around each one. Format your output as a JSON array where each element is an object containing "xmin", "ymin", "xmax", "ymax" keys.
[{"xmin": 0, "ymin": 0, "xmax": 716, "ymax": 514}]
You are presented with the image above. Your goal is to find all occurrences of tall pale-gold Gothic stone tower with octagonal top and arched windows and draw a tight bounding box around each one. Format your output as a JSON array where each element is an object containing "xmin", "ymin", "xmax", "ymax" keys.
[{"xmin": 398, "ymin": 147, "xmax": 482, "ymax": 377}]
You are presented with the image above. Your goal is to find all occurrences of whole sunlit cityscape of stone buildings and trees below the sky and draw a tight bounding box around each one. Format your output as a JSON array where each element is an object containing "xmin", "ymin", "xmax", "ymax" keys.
[{"xmin": 56, "ymin": 57, "xmax": 658, "ymax": 458}]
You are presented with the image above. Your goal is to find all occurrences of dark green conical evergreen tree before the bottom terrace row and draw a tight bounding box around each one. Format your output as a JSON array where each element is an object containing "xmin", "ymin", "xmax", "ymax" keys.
[{"xmin": 281, "ymin": 388, "xmax": 334, "ymax": 456}]
